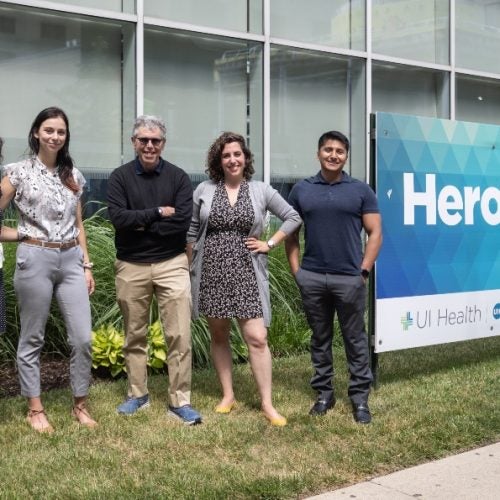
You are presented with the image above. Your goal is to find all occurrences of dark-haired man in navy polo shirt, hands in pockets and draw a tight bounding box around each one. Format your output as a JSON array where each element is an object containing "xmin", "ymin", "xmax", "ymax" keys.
[{"xmin": 286, "ymin": 131, "xmax": 382, "ymax": 424}]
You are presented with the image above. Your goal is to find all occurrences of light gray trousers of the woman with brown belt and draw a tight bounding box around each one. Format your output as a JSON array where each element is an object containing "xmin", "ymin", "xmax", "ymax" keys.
[{"xmin": 14, "ymin": 243, "xmax": 92, "ymax": 398}]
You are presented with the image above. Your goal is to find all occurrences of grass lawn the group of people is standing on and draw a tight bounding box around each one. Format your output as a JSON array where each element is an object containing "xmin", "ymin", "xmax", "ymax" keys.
[{"xmin": 0, "ymin": 337, "xmax": 500, "ymax": 499}]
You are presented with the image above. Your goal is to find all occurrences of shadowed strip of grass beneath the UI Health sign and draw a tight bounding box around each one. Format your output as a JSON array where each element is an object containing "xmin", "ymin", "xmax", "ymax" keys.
[{"xmin": 378, "ymin": 337, "xmax": 500, "ymax": 384}]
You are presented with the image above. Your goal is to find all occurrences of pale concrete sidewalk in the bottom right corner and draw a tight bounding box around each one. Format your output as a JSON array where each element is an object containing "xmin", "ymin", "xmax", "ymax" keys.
[{"xmin": 310, "ymin": 442, "xmax": 500, "ymax": 500}]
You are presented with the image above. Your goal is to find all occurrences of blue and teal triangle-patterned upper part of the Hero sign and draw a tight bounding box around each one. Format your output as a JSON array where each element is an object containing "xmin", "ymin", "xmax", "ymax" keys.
[{"xmin": 375, "ymin": 113, "xmax": 500, "ymax": 298}]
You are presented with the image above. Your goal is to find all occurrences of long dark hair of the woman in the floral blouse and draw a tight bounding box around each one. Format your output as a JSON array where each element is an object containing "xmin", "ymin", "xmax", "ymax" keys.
[{"xmin": 28, "ymin": 106, "xmax": 80, "ymax": 193}]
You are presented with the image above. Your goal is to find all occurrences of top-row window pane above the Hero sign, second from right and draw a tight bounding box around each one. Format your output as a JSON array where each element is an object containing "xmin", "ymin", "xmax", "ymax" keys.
[{"xmin": 372, "ymin": 0, "xmax": 450, "ymax": 64}]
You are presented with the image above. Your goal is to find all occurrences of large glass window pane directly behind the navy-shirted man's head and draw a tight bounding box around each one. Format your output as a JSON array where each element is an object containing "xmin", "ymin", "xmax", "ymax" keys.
[{"xmin": 271, "ymin": 47, "xmax": 366, "ymax": 191}]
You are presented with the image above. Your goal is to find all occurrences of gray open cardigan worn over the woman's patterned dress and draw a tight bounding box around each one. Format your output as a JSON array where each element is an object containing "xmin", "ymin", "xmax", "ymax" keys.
[{"xmin": 187, "ymin": 181, "xmax": 302, "ymax": 327}]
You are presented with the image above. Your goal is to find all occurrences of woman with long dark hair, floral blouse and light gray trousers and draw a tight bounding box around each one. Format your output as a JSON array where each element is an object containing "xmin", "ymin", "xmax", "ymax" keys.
[{"xmin": 0, "ymin": 107, "xmax": 97, "ymax": 432}]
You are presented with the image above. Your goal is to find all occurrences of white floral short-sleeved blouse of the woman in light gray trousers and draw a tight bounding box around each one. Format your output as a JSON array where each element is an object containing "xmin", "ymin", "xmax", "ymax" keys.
[{"xmin": 4, "ymin": 157, "xmax": 85, "ymax": 242}]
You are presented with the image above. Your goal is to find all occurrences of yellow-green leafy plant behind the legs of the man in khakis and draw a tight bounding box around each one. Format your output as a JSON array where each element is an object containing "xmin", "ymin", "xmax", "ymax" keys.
[{"xmin": 92, "ymin": 320, "xmax": 167, "ymax": 377}]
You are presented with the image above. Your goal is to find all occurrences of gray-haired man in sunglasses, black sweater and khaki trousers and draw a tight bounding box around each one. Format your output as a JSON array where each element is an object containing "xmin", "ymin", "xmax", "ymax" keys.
[{"xmin": 108, "ymin": 116, "xmax": 202, "ymax": 425}]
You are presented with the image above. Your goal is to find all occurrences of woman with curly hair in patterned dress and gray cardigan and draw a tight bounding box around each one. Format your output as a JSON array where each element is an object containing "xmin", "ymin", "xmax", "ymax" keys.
[{"xmin": 188, "ymin": 132, "xmax": 301, "ymax": 426}]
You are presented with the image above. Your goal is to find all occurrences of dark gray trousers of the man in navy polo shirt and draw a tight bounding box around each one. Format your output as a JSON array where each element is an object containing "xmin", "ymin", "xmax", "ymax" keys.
[{"xmin": 295, "ymin": 268, "xmax": 373, "ymax": 404}]
